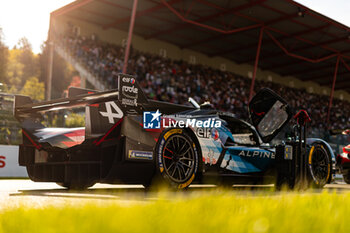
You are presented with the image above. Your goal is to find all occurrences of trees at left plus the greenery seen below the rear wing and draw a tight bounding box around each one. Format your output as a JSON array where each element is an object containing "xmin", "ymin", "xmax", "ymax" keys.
[{"xmin": 0, "ymin": 27, "xmax": 84, "ymax": 144}]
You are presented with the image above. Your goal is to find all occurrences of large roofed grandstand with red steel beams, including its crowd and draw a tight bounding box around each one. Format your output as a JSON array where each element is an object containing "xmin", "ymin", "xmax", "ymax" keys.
[{"xmin": 49, "ymin": 0, "xmax": 350, "ymax": 136}]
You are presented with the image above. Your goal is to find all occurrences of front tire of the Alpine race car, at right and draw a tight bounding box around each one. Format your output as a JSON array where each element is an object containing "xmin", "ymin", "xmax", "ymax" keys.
[{"xmin": 308, "ymin": 144, "xmax": 332, "ymax": 188}]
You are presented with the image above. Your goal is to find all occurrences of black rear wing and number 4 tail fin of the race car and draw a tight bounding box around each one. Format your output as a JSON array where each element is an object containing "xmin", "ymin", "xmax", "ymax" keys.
[{"xmin": 14, "ymin": 74, "xmax": 148, "ymax": 138}]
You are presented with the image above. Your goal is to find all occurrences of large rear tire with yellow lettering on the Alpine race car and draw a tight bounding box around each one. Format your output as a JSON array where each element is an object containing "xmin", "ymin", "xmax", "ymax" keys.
[{"xmin": 155, "ymin": 129, "xmax": 199, "ymax": 189}]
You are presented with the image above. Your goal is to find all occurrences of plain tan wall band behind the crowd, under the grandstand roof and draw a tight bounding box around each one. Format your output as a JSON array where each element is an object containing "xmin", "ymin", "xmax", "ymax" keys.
[{"xmin": 53, "ymin": 16, "xmax": 350, "ymax": 101}]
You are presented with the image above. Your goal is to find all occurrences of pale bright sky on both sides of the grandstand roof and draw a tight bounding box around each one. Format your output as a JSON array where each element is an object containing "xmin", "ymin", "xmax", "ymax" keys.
[{"xmin": 0, "ymin": 0, "xmax": 350, "ymax": 53}]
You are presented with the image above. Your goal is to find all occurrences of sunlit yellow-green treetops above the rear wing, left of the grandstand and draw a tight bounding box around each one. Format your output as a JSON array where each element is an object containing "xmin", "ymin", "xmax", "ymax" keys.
[{"xmin": 0, "ymin": 28, "xmax": 76, "ymax": 101}]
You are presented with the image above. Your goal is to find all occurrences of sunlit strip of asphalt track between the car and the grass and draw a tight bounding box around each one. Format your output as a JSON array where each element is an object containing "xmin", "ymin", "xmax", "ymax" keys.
[{"xmin": 0, "ymin": 179, "xmax": 350, "ymax": 209}]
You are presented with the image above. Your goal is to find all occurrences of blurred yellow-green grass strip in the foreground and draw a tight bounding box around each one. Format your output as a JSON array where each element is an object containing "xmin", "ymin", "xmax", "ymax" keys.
[{"xmin": 0, "ymin": 191, "xmax": 350, "ymax": 233}]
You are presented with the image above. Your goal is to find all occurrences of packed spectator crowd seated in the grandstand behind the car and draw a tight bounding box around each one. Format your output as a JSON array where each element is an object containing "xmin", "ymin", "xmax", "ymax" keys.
[{"xmin": 58, "ymin": 32, "xmax": 350, "ymax": 135}]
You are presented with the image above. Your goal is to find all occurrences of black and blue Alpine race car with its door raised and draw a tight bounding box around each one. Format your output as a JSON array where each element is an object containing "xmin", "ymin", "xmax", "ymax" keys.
[{"xmin": 14, "ymin": 74, "xmax": 335, "ymax": 189}]
